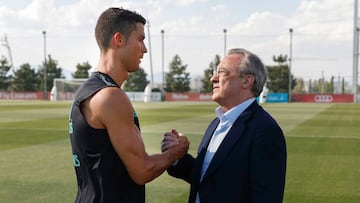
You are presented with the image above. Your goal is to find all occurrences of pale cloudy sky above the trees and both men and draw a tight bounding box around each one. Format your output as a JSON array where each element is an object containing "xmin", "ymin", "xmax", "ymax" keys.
[{"xmin": 0, "ymin": 0, "xmax": 354, "ymax": 83}]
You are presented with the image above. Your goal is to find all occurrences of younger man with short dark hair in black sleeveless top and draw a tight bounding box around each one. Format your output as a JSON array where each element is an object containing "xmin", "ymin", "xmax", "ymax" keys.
[{"xmin": 69, "ymin": 8, "xmax": 189, "ymax": 203}]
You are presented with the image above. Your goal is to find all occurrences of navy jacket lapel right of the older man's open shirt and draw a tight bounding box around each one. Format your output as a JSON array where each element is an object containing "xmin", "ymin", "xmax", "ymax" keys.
[{"xmin": 201, "ymin": 102, "xmax": 258, "ymax": 180}]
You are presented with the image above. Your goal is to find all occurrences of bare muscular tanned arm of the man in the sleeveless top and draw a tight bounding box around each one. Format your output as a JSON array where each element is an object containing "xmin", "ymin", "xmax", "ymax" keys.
[{"xmin": 84, "ymin": 88, "xmax": 189, "ymax": 185}]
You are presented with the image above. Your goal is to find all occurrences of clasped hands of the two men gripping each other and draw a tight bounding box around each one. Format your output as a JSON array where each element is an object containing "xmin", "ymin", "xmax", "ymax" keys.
[{"xmin": 161, "ymin": 129, "xmax": 190, "ymax": 162}]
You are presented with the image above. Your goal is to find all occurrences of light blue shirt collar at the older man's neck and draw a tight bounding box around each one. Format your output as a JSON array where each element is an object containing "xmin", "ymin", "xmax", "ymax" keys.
[{"xmin": 215, "ymin": 98, "xmax": 255, "ymax": 125}]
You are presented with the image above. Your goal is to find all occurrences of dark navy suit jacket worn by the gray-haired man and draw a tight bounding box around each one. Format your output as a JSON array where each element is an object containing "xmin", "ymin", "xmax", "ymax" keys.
[{"xmin": 168, "ymin": 101, "xmax": 286, "ymax": 203}]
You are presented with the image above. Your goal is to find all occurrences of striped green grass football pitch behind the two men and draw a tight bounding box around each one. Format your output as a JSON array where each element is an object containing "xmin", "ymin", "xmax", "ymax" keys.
[{"xmin": 0, "ymin": 101, "xmax": 360, "ymax": 203}]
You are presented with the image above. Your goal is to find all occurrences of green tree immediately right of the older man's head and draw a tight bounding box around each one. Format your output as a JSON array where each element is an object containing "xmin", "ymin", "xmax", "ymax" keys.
[{"xmin": 266, "ymin": 55, "xmax": 296, "ymax": 93}]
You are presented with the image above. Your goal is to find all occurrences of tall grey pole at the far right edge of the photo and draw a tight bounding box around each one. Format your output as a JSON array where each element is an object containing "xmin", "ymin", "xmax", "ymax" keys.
[{"xmin": 353, "ymin": 0, "xmax": 359, "ymax": 103}]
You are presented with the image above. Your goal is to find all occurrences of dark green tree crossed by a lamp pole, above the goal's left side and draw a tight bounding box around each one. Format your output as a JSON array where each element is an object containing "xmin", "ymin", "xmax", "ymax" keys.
[{"xmin": 37, "ymin": 55, "xmax": 65, "ymax": 91}]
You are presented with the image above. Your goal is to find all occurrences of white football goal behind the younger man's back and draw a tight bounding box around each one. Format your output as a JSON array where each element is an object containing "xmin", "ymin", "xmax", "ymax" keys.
[{"xmin": 50, "ymin": 78, "xmax": 88, "ymax": 101}]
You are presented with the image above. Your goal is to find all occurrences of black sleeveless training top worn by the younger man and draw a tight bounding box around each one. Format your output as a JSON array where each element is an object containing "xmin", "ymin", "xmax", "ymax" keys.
[{"xmin": 69, "ymin": 72, "xmax": 145, "ymax": 203}]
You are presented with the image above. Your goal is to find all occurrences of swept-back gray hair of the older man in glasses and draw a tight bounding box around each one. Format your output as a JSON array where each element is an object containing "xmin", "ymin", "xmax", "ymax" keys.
[{"xmin": 228, "ymin": 48, "xmax": 266, "ymax": 97}]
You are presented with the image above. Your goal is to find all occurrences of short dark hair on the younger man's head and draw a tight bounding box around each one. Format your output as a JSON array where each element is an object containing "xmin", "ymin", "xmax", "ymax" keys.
[{"xmin": 95, "ymin": 8, "xmax": 146, "ymax": 51}]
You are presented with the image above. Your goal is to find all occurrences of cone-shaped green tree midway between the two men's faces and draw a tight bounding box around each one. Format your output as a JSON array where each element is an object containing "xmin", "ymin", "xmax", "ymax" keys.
[{"xmin": 165, "ymin": 54, "xmax": 190, "ymax": 92}]
